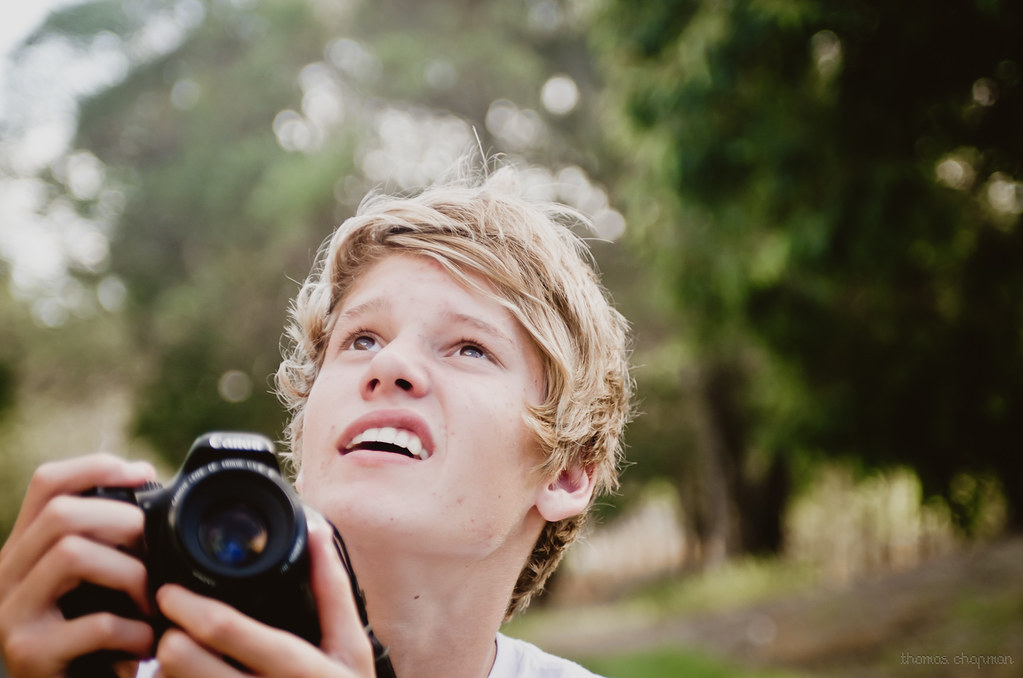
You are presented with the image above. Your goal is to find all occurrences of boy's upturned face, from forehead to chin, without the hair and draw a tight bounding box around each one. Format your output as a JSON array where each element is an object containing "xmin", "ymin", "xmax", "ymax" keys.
[{"xmin": 298, "ymin": 255, "xmax": 544, "ymax": 557}]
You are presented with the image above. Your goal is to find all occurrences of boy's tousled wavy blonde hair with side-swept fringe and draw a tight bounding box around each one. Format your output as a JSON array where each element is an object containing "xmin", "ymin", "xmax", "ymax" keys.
[{"xmin": 276, "ymin": 168, "xmax": 632, "ymax": 619}]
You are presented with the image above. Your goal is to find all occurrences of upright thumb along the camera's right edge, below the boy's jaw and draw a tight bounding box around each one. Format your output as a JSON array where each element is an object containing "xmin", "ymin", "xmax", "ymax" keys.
[{"xmin": 309, "ymin": 515, "xmax": 373, "ymax": 675}]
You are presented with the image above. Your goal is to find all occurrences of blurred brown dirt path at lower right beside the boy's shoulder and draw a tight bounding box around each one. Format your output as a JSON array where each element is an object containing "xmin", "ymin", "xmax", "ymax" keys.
[{"xmin": 531, "ymin": 539, "xmax": 1023, "ymax": 678}]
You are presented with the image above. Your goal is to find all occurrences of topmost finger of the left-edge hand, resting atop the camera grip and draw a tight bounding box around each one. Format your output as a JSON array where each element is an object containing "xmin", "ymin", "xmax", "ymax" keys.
[{"xmin": 0, "ymin": 452, "xmax": 157, "ymax": 556}]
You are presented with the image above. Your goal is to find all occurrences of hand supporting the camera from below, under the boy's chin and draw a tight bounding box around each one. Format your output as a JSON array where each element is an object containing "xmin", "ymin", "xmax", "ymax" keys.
[{"xmin": 157, "ymin": 516, "xmax": 375, "ymax": 678}]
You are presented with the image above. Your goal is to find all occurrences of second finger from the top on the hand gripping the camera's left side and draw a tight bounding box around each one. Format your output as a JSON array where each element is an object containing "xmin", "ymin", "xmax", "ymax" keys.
[{"xmin": 0, "ymin": 496, "xmax": 144, "ymax": 598}]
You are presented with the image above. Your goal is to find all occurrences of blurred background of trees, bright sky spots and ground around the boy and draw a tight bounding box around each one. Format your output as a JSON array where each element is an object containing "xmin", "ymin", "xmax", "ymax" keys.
[{"xmin": 0, "ymin": 0, "xmax": 1023, "ymax": 678}]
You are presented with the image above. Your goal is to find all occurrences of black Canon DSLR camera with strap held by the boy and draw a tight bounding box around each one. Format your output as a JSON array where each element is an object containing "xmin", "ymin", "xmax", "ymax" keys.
[{"xmin": 58, "ymin": 433, "xmax": 394, "ymax": 678}]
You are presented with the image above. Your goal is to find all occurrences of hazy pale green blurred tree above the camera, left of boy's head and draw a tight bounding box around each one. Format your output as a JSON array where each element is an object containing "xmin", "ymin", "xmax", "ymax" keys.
[{"xmin": 64, "ymin": 2, "xmax": 351, "ymax": 459}]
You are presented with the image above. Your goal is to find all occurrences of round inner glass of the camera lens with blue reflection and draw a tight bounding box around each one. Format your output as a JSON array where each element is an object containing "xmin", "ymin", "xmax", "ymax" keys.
[{"xmin": 198, "ymin": 502, "xmax": 269, "ymax": 568}]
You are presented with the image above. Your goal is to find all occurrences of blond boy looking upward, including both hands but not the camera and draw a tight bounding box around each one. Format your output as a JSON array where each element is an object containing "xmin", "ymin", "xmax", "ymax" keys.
[{"xmin": 0, "ymin": 164, "xmax": 631, "ymax": 678}]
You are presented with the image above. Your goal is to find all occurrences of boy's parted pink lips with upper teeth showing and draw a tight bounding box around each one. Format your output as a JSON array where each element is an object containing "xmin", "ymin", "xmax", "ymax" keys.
[{"xmin": 338, "ymin": 410, "xmax": 434, "ymax": 461}]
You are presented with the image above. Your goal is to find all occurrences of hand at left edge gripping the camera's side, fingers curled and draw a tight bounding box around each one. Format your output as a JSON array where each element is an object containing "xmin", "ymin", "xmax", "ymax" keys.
[{"xmin": 0, "ymin": 454, "xmax": 155, "ymax": 678}]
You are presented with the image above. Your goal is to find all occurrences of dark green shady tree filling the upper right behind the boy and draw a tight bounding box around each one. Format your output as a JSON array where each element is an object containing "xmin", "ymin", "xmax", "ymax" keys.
[{"xmin": 594, "ymin": 0, "xmax": 1023, "ymax": 549}]
